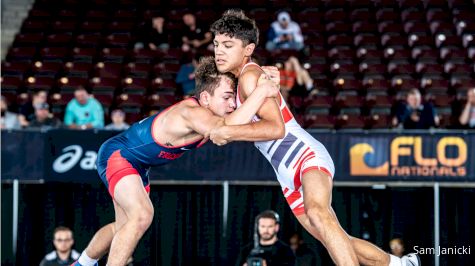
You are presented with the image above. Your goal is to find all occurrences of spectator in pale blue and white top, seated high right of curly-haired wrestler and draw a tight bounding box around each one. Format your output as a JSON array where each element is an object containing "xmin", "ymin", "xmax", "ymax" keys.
[{"xmin": 266, "ymin": 11, "xmax": 304, "ymax": 51}]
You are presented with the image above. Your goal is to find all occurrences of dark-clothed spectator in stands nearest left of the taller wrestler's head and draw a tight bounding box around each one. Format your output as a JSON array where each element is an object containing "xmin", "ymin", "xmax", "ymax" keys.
[{"xmin": 181, "ymin": 13, "xmax": 214, "ymax": 52}]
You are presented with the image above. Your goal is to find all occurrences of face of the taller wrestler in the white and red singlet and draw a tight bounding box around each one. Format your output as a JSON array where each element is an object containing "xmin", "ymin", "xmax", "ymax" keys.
[{"xmin": 213, "ymin": 34, "xmax": 255, "ymax": 77}]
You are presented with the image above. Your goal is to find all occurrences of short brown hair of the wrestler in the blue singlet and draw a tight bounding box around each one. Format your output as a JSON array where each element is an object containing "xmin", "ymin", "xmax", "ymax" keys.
[{"xmin": 194, "ymin": 56, "xmax": 237, "ymax": 98}]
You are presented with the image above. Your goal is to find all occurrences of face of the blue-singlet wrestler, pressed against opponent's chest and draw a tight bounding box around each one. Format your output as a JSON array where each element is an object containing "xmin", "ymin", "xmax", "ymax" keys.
[{"xmin": 205, "ymin": 76, "xmax": 236, "ymax": 117}]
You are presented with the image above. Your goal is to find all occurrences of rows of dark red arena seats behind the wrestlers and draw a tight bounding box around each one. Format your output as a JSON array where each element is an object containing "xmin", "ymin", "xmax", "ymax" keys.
[{"xmin": 1, "ymin": 0, "xmax": 475, "ymax": 129}]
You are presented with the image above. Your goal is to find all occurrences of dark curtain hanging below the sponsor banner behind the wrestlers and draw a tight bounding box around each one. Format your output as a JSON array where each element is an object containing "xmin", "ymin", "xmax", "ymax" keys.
[{"xmin": 1, "ymin": 183, "xmax": 475, "ymax": 265}]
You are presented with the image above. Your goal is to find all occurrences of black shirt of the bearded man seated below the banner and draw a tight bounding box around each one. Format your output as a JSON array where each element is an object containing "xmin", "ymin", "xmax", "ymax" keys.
[{"xmin": 236, "ymin": 240, "xmax": 295, "ymax": 266}]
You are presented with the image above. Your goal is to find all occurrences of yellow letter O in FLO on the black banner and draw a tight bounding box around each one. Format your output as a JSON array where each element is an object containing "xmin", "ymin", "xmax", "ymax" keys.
[{"xmin": 437, "ymin": 137, "xmax": 467, "ymax": 167}]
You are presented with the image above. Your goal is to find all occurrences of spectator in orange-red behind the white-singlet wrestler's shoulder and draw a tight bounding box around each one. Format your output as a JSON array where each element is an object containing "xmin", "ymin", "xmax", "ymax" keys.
[{"xmin": 280, "ymin": 56, "xmax": 313, "ymax": 100}]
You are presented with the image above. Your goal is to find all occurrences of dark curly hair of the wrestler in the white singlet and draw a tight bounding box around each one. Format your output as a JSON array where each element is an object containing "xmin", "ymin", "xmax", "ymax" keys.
[{"xmin": 211, "ymin": 9, "xmax": 259, "ymax": 46}]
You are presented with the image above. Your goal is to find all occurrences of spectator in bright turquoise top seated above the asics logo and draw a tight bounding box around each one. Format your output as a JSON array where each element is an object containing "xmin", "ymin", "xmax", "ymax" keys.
[{"xmin": 64, "ymin": 87, "xmax": 104, "ymax": 129}]
